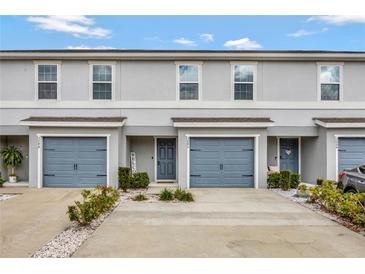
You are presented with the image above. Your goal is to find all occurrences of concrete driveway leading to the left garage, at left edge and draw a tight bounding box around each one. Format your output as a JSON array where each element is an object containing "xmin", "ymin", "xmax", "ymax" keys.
[{"xmin": 0, "ymin": 187, "xmax": 80, "ymax": 258}]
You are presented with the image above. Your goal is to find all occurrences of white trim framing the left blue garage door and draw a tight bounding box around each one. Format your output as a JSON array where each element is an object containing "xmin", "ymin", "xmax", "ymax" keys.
[{"xmin": 37, "ymin": 133, "xmax": 110, "ymax": 188}]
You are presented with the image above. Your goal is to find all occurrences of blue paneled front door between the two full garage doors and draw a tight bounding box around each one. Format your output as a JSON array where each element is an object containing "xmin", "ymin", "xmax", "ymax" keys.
[{"xmin": 157, "ymin": 138, "xmax": 176, "ymax": 180}]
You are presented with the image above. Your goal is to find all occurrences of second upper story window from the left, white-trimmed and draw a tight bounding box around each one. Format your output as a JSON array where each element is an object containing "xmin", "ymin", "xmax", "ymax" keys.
[{"xmin": 92, "ymin": 64, "xmax": 113, "ymax": 100}]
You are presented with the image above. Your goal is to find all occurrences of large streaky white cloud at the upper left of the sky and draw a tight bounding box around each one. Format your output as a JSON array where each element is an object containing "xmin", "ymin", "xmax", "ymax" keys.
[{"xmin": 27, "ymin": 15, "xmax": 111, "ymax": 38}]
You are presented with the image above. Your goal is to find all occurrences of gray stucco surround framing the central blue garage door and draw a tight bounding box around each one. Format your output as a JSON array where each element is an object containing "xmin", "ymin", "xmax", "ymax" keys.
[{"xmin": 177, "ymin": 128, "xmax": 267, "ymax": 188}]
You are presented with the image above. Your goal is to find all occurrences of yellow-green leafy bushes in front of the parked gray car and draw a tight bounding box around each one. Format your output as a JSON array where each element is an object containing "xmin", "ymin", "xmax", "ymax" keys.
[{"xmin": 308, "ymin": 180, "xmax": 365, "ymax": 226}]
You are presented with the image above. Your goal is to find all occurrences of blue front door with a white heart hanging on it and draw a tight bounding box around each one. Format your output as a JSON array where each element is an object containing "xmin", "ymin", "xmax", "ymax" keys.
[{"xmin": 280, "ymin": 138, "xmax": 299, "ymax": 173}]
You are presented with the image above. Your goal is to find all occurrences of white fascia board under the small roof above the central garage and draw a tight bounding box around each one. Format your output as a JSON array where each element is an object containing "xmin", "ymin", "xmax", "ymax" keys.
[{"xmin": 173, "ymin": 122, "xmax": 274, "ymax": 128}]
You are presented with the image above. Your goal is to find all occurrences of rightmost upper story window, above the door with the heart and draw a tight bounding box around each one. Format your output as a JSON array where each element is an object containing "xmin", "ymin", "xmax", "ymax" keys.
[{"xmin": 319, "ymin": 64, "xmax": 343, "ymax": 101}]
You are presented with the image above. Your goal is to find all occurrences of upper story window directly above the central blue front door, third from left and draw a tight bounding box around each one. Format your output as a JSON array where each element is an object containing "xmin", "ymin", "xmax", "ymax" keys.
[{"xmin": 177, "ymin": 64, "xmax": 201, "ymax": 100}]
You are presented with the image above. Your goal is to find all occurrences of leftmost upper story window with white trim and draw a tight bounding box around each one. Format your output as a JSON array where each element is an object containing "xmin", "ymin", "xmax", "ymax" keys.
[{"xmin": 36, "ymin": 63, "xmax": 60, "ymax": 100}]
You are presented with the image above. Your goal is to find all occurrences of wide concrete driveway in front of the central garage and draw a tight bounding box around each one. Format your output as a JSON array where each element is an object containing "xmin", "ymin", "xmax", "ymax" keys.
[{"xmin": 75, "ymin": 189, "xmax": 365, "ymax": 257}]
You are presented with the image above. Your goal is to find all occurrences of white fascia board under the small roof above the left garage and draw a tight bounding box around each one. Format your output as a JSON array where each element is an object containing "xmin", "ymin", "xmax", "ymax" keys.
[{"xmin": 19, "ymin": 121, "xmax": 125, "ymax": 127}]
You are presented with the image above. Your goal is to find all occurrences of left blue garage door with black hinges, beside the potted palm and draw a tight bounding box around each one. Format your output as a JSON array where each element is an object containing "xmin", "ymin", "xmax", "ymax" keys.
[{"xmin": 43, "ymin": 137, "xmax": 107, "ymax": 187}]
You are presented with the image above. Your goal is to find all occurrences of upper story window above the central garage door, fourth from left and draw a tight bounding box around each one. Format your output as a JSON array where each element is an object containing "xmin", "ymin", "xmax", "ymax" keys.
[{"xmin": 232, "ymin": 63, "xmax": 257, "ymax": 100}]
